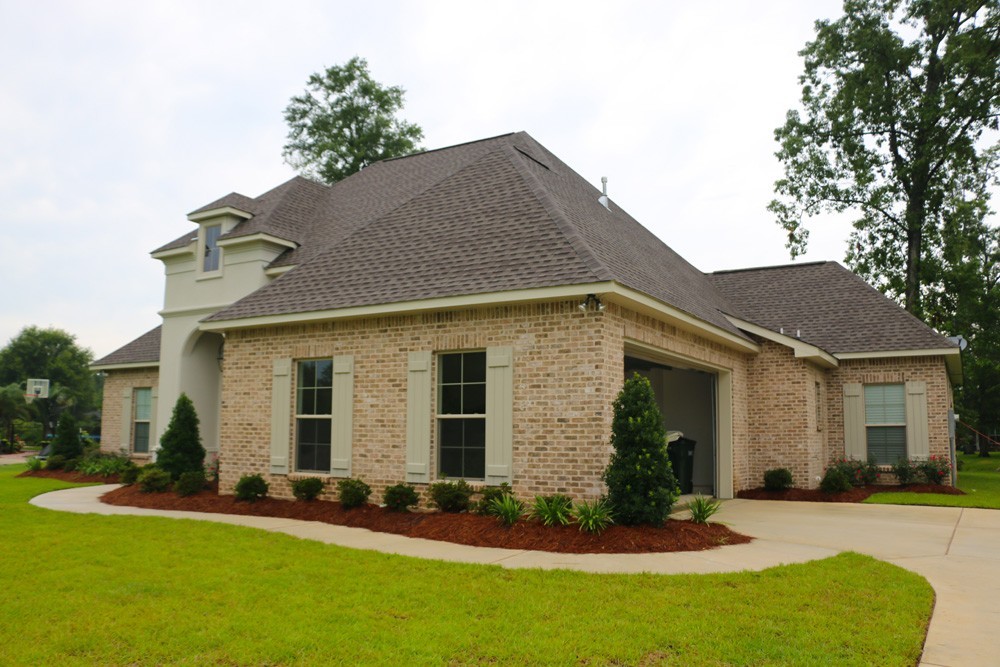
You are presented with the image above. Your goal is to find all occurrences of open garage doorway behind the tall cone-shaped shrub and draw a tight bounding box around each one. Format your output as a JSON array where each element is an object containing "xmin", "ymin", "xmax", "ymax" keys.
[{"xmin": 625, "ymin": 354, "xmax": 724, "ymax": 497}]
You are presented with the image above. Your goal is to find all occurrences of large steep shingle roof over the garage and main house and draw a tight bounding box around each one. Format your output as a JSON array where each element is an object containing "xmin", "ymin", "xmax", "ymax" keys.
[{"xmin": 203, "ymin": 132, "xmax": 743, "ymax": 335}]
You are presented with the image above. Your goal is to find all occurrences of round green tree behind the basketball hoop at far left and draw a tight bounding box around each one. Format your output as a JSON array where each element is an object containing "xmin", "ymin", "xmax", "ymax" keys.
[{"xmin": 0, "ymin": 326, "xmax": 100, "ymax": 433}]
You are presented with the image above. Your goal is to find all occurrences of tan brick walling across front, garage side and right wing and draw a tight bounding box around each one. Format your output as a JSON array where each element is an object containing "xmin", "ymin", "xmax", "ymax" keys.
[{"xmin": 213, "ymin": 300, "xmax": 950, "ymax": 500}]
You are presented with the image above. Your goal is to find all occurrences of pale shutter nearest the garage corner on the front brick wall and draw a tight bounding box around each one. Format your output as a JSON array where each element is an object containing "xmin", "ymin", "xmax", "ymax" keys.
[{"xmin": 486, "ymin": 347, "xmax": 514, "ymax": 485}]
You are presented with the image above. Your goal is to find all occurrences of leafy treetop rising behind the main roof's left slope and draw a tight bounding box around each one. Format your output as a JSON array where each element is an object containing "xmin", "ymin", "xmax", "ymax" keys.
[{"xmin": 282, "ymin": 56, "xmax": 424, "ymax": 184}]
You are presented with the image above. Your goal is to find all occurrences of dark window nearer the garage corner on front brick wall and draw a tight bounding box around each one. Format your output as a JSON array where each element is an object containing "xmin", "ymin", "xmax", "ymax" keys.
[{"xmin": 437, "ymin": 352, "xmax": 486, "ymax": 479}]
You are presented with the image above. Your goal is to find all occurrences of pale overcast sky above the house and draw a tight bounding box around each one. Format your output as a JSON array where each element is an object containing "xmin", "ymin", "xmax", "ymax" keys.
[{"xmin": 0, "ymin": 0, "xmax": 850, "ymax": 357}]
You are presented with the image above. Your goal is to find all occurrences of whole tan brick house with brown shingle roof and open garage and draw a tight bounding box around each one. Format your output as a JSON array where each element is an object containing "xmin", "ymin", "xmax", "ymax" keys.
[{"xmin": 94, "ymin": 132, "xmax": 961, "ymax": 499}]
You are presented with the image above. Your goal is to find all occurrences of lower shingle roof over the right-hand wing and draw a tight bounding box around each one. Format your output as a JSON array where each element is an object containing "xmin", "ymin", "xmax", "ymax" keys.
[{"xmin": 709, "ymin": 262, "xmax": 955, "ymax": 354}]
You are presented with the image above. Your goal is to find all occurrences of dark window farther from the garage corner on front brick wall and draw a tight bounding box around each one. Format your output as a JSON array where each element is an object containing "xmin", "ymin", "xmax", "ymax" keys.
[{"xmin": 296, "ymin": 359, "xmax": 333, "ymax": 472}]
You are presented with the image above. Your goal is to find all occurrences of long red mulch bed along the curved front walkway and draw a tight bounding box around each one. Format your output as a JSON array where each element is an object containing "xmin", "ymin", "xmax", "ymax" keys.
[{"xmin": 95, "ymin": 486, "xmax": 752, "ymax": 553}]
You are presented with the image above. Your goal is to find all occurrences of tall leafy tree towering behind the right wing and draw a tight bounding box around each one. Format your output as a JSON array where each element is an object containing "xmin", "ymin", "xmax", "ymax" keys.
[{"xmin": 768, "ymin": 0, "xmax": 1000, "ymax": 316}]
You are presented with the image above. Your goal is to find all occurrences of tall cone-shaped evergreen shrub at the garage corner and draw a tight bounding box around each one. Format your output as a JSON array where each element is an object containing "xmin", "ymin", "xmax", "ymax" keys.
[{"xmin": 604, "ymin": 373, "xmax": 678, "ymax": 526}]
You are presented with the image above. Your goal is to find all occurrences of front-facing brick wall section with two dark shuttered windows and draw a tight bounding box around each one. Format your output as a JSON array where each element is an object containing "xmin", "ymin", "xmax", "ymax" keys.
[{"xmin": 220, "ymin": 300, "xmax": 623, "ymax": 499}]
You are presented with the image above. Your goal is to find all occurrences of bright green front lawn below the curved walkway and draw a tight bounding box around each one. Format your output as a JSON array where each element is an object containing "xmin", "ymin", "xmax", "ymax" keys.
[{"xmin": 0, "ymin": 466, "xmax": 933, "ymax": 665}]
